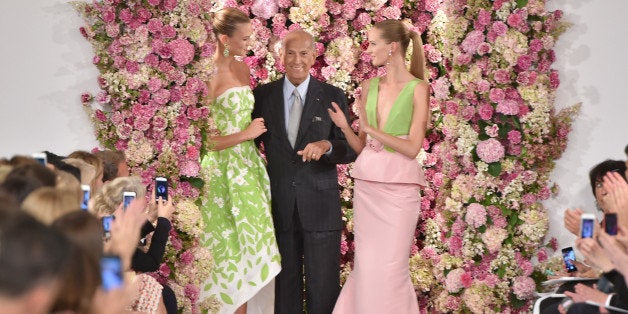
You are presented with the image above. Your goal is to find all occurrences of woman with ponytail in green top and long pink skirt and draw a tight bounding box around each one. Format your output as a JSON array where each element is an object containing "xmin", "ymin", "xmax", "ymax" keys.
[{"xmin": 329, "ymin": 20, "xmax": 429, "ymax": 314}]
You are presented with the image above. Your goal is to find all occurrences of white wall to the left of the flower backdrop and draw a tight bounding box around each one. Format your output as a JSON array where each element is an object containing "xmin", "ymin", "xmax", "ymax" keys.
[{"xmin": 0, "ymin": 0, "xmax": 98, "ymax": 157}]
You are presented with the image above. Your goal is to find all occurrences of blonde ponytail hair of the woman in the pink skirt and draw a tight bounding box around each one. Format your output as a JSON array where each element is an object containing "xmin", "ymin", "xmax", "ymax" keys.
[{"xmin": 373, "ymin": 20, "xmax": 429, "ymax": 81}]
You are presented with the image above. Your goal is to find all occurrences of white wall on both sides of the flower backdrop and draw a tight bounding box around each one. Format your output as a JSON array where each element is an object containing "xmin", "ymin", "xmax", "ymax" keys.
[{"xmin": 0, "ymin": 0, "xmax": 628, "ymax": 246}]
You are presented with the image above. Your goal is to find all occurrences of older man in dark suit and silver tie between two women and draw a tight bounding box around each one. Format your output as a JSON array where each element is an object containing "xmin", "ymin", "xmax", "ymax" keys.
[{"xmin": 253, "ymin": 31, "xmax": 355, "ymax": 314}]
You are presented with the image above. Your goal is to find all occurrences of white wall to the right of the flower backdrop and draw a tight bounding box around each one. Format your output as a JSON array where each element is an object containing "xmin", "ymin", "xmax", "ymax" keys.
[{"xmin": 545, "ymin": 0, "xmax": 628, "ymax": 250}]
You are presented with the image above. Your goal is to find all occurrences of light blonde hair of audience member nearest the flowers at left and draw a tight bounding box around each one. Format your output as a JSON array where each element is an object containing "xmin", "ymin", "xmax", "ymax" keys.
[{"xmin": 93, "ymin": 176, "xmax": 146, "ymax": 217}]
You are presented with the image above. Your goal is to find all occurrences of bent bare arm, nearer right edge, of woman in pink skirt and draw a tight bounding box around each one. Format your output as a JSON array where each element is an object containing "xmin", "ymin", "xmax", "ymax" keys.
[{"xmin": 360, "ymin": 82, "xmax": 430, "ymax": 158}]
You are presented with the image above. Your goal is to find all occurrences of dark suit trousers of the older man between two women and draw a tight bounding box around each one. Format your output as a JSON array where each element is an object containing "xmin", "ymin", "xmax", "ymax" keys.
[{"xmin": 275, "ymin": 205, "xmax": 341, "ymax": 314}]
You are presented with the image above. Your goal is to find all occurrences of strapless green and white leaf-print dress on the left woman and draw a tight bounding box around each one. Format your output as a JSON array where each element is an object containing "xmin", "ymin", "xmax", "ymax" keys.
[{"xmin": 200, "ymin": 86, "xmax": 281, "ymax": 313}]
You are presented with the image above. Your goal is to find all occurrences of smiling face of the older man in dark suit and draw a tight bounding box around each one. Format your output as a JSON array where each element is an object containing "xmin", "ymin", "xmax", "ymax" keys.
[{"xmin": 280, "ymin": 34, "xmax": 316, "ymax": 86}]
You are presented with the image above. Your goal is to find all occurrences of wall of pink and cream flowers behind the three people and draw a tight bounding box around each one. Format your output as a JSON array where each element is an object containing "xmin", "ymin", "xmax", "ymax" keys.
[{"xmin": 74, "ymin": 0, "xmax": 577, "ymax": 313}]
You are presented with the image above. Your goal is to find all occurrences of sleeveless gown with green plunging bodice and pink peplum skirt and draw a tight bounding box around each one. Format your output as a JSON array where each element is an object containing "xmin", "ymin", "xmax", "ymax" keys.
[{"xmin": 334, "ymin": 77, "xmax": 426, "ymax": 314}]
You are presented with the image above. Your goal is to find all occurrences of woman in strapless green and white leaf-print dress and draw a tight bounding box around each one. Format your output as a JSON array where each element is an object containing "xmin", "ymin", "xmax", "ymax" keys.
[{"xmin": 201, "ymin": 8, "xmax": 281, "ymax": 313}]
